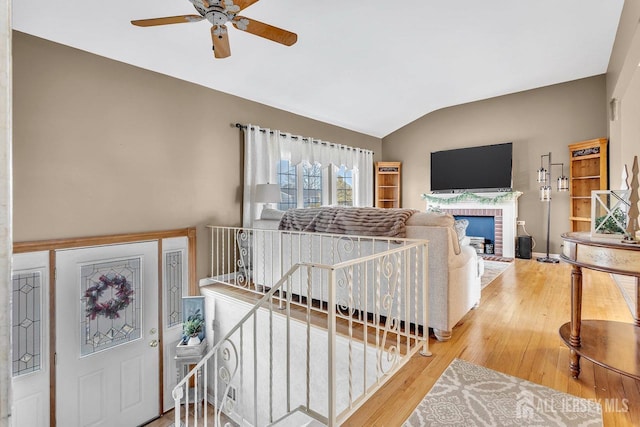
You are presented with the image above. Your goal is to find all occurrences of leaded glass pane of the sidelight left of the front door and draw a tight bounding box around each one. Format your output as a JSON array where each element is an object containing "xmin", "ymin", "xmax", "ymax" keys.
[{"xmin": 12, "ymin": 271, "xmax": 42, "ymax": 377}]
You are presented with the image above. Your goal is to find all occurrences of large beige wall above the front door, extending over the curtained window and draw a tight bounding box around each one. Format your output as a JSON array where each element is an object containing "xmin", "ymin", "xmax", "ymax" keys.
[{"xmin": 13, "ymin": 32, "xmax": 381, "ymax": 277}]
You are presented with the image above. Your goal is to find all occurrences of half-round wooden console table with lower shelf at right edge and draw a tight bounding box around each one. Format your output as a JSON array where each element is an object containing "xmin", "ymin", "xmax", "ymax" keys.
[{"xmin": 560, "ymin": 232, "xmax": 640, "ymax": 380}]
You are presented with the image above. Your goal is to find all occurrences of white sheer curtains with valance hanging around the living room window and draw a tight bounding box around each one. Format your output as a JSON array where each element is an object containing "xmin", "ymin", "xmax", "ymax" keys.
[{"xmin": 242, "ymin": 124, "xmax": 373, "ymax": 227}]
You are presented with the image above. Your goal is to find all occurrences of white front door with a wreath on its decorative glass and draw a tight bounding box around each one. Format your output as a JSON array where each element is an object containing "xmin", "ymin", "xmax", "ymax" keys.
[{"xmin": 55, "ymin": 242, "xmax": 160, "ymax": 427}]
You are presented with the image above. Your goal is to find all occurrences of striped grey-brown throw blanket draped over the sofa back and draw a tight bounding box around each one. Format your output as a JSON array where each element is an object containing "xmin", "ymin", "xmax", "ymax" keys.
[{"xmin": 278, "ymin": 207, "xmax": 418, "ymax": 238}]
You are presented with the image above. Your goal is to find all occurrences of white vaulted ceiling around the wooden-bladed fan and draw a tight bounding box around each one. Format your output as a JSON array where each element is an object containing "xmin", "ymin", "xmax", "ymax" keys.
[{"xmin": 12, "ymin": 0, "xmax": 624, "ymax": 137}]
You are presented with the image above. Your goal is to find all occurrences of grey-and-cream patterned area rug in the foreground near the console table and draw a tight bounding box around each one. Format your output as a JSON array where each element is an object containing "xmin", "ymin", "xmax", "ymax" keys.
[{"xmin": 403, "ymin": 359, "xmax": 603, "ymax": 427}]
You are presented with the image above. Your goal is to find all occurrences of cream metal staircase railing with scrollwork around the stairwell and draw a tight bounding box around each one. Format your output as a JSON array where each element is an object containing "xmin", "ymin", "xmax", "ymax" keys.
[{"xmin": 173, "ymin": 227, "xmax": 429, "ymax": 426}]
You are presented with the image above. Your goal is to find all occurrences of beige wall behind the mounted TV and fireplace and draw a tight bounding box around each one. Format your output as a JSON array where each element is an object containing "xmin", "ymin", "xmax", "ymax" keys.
[{"xmin": 382, "ymin": 76, "xmax": 607, "ymax": 253}]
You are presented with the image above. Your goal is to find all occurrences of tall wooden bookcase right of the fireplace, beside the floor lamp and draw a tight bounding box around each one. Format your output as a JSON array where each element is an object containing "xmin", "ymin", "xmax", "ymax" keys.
[{"xmin": 569, "ymin": 138, "xmax": 609, "ymax": 231}]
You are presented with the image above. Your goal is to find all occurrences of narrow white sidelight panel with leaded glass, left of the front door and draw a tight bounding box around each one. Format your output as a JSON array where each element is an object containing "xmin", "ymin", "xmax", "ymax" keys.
[{"xmin": 11, "ymin": 251, "xmax": 50, "ymax": 427}]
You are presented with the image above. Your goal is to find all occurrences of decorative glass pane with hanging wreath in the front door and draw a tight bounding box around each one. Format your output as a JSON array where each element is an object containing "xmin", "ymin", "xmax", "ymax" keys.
[{"xmin": 80, "ymin": 257, "xmax": 142, "ymax": 356}]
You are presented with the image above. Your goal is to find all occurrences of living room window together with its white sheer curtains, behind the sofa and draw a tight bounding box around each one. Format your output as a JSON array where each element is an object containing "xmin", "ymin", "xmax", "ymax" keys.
[{"xmin": 242, "ymin": 125, "xmax": 373, "ymax": 227}]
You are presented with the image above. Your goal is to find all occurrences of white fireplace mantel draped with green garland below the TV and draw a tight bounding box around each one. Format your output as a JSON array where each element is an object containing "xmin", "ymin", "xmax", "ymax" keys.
[{"xmin": 422, "ymin": 191, "xmax": 522, "ymax": 258}]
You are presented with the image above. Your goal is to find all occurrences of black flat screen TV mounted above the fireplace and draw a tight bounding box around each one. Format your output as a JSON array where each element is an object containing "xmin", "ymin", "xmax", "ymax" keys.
[{"xmin": 431, "ymin": 142, "xmax": 513, "ymax": 193}]
